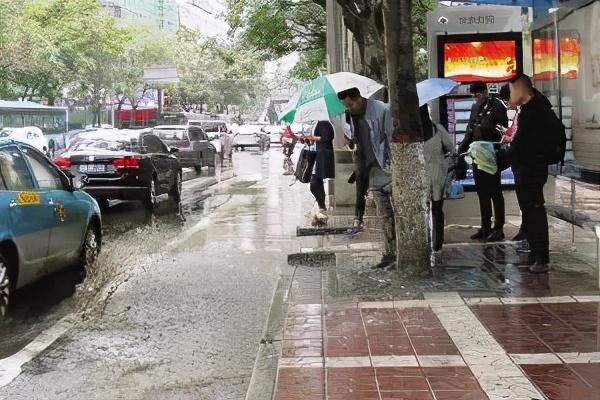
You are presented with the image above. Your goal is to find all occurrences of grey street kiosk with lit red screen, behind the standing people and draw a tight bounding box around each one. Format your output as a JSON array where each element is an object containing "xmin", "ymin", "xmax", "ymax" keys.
[{"xmin": 427, "ymin": 6, "xmax": 523, "ymax": 190}]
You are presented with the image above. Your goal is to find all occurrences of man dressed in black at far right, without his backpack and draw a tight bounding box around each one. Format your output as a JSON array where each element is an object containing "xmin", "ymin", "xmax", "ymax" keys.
[{"xmin": 509, "ymin": 75, "xmax": 556, "ymax": 273}]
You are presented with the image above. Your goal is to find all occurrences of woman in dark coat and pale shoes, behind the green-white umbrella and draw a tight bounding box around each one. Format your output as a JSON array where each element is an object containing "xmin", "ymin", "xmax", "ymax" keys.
[{"xmin": 304, "ymin": 121, "xmax": 335, "ymax": 222}]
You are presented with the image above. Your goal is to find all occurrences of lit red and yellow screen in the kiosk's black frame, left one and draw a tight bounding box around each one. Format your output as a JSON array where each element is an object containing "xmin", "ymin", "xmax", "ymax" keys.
[{"xmin": 444, "ymin": 40, "xmax": 517, "ymax": 83}]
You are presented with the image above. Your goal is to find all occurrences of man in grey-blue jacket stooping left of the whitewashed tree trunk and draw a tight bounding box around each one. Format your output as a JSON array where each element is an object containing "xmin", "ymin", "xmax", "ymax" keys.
[{"xmin": 338, "ymin": 88, "xmax": 396, "ymax": 268}]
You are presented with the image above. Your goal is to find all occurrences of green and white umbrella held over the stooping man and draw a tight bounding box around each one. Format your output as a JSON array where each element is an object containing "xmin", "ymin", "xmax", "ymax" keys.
[{"xmin": 279, "ymin": 72, "xmax": 383, "ymax": 123}]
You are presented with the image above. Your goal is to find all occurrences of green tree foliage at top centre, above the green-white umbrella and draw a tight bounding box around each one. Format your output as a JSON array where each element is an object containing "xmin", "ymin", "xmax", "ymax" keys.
[{"xmin": 227, "ymin": 0, "xmax": 327, "ymax": 79}]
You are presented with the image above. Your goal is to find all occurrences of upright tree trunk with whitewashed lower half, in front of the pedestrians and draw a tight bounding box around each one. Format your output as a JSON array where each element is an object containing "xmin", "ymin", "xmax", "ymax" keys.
[{"xmin": 383, "ymin": 0, "xmax": 429, "ymax": 270}]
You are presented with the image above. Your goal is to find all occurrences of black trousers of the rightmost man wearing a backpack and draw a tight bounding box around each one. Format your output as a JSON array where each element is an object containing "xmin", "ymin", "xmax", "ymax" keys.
[{"xmin": 515, "ymin": 182, "xmax": 550, "ymax": 264}]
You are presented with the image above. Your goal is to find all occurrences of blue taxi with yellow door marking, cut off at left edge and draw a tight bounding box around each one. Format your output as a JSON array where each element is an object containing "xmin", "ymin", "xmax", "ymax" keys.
[{"xmin": 0, "ymin": 138, "xmax": 102, "ymax": 316}]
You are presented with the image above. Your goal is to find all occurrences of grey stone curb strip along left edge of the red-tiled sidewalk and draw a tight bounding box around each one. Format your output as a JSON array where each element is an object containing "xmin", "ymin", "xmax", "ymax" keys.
[{"xmin": 246, "ymin": 275, "xmax": 292, "ymax": 400}]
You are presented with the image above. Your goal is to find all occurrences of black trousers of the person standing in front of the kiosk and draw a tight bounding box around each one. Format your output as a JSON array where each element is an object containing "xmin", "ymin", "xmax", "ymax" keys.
[{"xmin": 473, "ymin": 167, "xmax": 505, "ymax": 231}]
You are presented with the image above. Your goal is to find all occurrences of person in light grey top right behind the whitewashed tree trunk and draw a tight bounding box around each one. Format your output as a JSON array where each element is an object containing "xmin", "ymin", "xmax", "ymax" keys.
[{"xmin": 420, "ymin": 105, "xmax": 453, "ymax": 251}]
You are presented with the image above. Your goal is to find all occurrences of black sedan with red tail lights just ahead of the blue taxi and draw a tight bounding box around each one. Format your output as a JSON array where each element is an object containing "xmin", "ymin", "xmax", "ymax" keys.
[{"xmin": 54, "ymin": 129, "xmax": 182, "ymax": 212}]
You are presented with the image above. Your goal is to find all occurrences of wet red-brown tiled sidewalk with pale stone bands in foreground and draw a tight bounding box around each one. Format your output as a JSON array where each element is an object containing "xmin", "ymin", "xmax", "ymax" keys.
[{"xmin": 275, "ymin": 273, "xmax": 600, "ymax": 400}]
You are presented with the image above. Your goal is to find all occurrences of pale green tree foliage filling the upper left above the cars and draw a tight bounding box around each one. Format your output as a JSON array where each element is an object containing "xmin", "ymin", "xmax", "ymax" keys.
[{"xmin": 0, "ymin": 0, "xmax": 268, "ymax": 121}]
